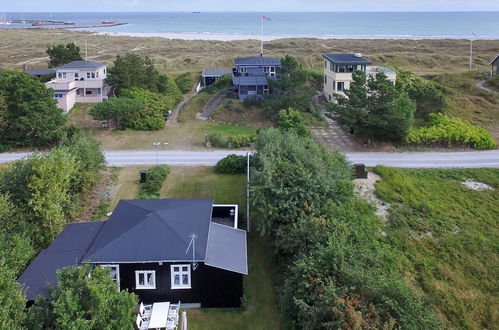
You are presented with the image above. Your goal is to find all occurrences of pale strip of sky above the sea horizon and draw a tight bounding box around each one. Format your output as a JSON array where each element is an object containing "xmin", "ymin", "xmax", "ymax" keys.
[{"xmin": 0, "ymin": 0, "xmax": 499, "ymax": 12}]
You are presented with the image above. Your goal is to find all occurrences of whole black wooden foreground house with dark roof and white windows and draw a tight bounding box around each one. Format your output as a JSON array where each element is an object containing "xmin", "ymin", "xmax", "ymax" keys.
[{"xmin": 19, "ymin": 199, "xmax": 248, "ymax": 307}]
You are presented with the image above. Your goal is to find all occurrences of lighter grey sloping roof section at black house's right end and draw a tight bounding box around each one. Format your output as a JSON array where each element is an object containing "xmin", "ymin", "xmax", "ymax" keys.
[{"xmin": 205, "ymin": 222, "xmax": 248, "ymax": 275}]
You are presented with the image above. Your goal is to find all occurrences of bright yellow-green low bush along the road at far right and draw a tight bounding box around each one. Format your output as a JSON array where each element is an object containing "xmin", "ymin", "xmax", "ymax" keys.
[{"xmin": 406, "ymin": 114, "xmax": 496, "ymax": 149}]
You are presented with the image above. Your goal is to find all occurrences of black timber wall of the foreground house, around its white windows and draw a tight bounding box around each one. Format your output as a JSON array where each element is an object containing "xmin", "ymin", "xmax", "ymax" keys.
[{"xmin": 116, "ymin": 263, "xmax": 243, "ymax": 307}]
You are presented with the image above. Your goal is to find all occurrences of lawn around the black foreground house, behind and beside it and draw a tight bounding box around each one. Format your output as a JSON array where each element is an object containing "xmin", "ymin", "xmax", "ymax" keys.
[{"xmin": 111, "ymin": 166, "xmax": 281, "ymax": 330}]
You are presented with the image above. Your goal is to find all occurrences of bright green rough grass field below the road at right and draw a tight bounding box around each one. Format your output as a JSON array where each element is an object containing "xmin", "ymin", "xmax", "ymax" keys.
[{"xmin": 374, "ymin": 167, "xmax": 499, "ymax": 329}]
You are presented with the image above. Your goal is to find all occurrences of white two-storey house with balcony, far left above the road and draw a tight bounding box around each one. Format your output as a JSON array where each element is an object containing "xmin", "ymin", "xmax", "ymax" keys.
[{"xmin": 45, "ymin": 61, "xmax": 109, "ymax": 113}]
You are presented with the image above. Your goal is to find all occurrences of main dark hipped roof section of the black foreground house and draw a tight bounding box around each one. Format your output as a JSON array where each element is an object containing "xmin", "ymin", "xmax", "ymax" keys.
[{"xmin": 84, "ymin": 199, "xmax": 213, "ymax": 263}]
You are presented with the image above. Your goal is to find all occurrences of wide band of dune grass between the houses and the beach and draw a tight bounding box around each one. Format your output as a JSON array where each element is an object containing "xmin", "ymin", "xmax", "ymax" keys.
[{"xmin": 0, "ymin": 29, "xmax": 499, "ymax": 74}]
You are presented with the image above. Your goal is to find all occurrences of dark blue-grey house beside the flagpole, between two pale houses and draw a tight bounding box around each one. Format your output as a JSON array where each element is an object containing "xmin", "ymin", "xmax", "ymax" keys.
[{"xmin": 201, "ymin": 56, "xmax": 281, "ymax": 100}]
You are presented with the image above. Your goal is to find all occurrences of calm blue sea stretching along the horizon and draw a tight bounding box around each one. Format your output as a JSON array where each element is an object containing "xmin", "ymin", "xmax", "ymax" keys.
[{"xmin": 0, "ymin": 12, "xmax": 499, "ymax": 39}]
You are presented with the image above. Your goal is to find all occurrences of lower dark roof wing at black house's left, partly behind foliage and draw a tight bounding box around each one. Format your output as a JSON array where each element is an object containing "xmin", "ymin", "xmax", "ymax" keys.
[{"xmin": 18, "ymin": 221, "xmax": 105, "ymax": 300}]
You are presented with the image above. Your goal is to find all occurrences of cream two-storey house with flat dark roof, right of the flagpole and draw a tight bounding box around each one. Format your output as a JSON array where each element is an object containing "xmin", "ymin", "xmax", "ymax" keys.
[{"xmin": 322, "ymin": 53, "xmax": 397, "ymax": 102}]
